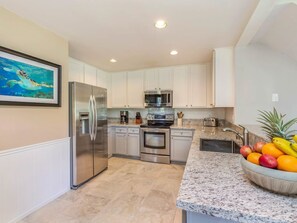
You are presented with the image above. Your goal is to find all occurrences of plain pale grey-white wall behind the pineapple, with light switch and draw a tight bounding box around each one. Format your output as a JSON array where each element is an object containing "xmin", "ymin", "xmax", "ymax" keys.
[{"xmin": 235, "ymin": 44, "xmax": 297, "ymax": 125}]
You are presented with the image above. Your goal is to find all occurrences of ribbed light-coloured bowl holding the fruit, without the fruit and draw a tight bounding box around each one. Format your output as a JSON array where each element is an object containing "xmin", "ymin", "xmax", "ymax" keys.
[{"xmin": 240, "ymin": 157, "xmax": 297, "ymax": 194}]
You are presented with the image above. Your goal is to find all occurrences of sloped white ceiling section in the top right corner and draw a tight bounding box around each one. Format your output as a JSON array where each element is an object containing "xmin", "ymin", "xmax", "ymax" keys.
[{"xmin": 252, "ymin": 3, "xmax": 297, "ymax": 61}]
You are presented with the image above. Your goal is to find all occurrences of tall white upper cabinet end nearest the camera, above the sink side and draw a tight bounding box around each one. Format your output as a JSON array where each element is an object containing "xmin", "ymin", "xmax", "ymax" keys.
[{"xmin": 213, "ymin": 47, "xmax": 235, "ymax": 107}]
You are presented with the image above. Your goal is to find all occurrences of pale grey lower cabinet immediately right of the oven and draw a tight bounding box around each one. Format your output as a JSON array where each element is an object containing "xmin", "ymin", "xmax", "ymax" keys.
[{"xmin": 171, "ymin": 130, "xmax": 193, "ymax": 162}]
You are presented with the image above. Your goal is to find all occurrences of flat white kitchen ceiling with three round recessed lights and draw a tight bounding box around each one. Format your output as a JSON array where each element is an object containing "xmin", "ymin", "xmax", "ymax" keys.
[{"xmin": 0, "ymin": 0, "xmax": 259, "ymax": 71}]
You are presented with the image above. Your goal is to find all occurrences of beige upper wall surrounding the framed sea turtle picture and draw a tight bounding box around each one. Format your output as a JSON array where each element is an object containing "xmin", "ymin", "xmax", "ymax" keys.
[{"xmin": 0, "ymin": 7, "xmax": 68, "ymax": 150}]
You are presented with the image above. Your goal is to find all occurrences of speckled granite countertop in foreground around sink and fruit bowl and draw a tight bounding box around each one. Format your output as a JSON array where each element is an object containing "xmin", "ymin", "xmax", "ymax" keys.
[{"xmin": 176, "ymin": 126, "xmax": 297, "ymax": 223}]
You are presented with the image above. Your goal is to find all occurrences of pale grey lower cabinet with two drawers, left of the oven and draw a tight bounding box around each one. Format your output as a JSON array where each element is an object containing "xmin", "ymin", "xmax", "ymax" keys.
[{"xmin": 115, "ymin": 127, "xmax": 140, "ymax": 156}]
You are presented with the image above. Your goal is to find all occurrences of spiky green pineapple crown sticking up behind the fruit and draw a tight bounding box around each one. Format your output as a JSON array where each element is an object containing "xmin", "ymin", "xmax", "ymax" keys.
[{"xmin": 258, "ymin": 108, "xmax": 297, "ymax": 140}]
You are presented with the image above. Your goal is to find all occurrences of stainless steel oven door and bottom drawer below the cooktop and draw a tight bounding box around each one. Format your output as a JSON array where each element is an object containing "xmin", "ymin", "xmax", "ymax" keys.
[{"xmin": 140, "ymin": 128, "xmax": 170, "ymax": 163}]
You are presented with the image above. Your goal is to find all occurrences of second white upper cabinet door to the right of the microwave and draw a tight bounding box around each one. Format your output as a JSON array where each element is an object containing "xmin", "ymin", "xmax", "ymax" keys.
[{"xmin": 189, "ymin": 65, "xmax": 207, "ymax": 108}]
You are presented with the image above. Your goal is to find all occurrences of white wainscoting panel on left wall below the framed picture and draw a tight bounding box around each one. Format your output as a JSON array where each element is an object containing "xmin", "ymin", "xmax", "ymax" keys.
[{"xmin": 0, "ymin": 138, "xmax": 70, "ymax": 223}]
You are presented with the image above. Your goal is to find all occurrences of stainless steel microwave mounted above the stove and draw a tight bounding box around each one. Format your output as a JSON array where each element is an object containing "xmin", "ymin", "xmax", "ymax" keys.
[{"xmin": 144, "ymin": 90, "xmax": 173, "ymax": 108}]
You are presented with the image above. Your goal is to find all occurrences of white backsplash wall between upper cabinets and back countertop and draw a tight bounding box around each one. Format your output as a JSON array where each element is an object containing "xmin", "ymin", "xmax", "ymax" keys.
[{"xmin": 108, "ymin": 108, "xmax": 225, "ymax": 119}]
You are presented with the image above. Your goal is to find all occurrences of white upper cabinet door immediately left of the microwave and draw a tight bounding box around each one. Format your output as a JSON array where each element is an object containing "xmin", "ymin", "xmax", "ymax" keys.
[{"xmin": 127, "ymin": 70, "xmax": 144, "ymax": 108}]
